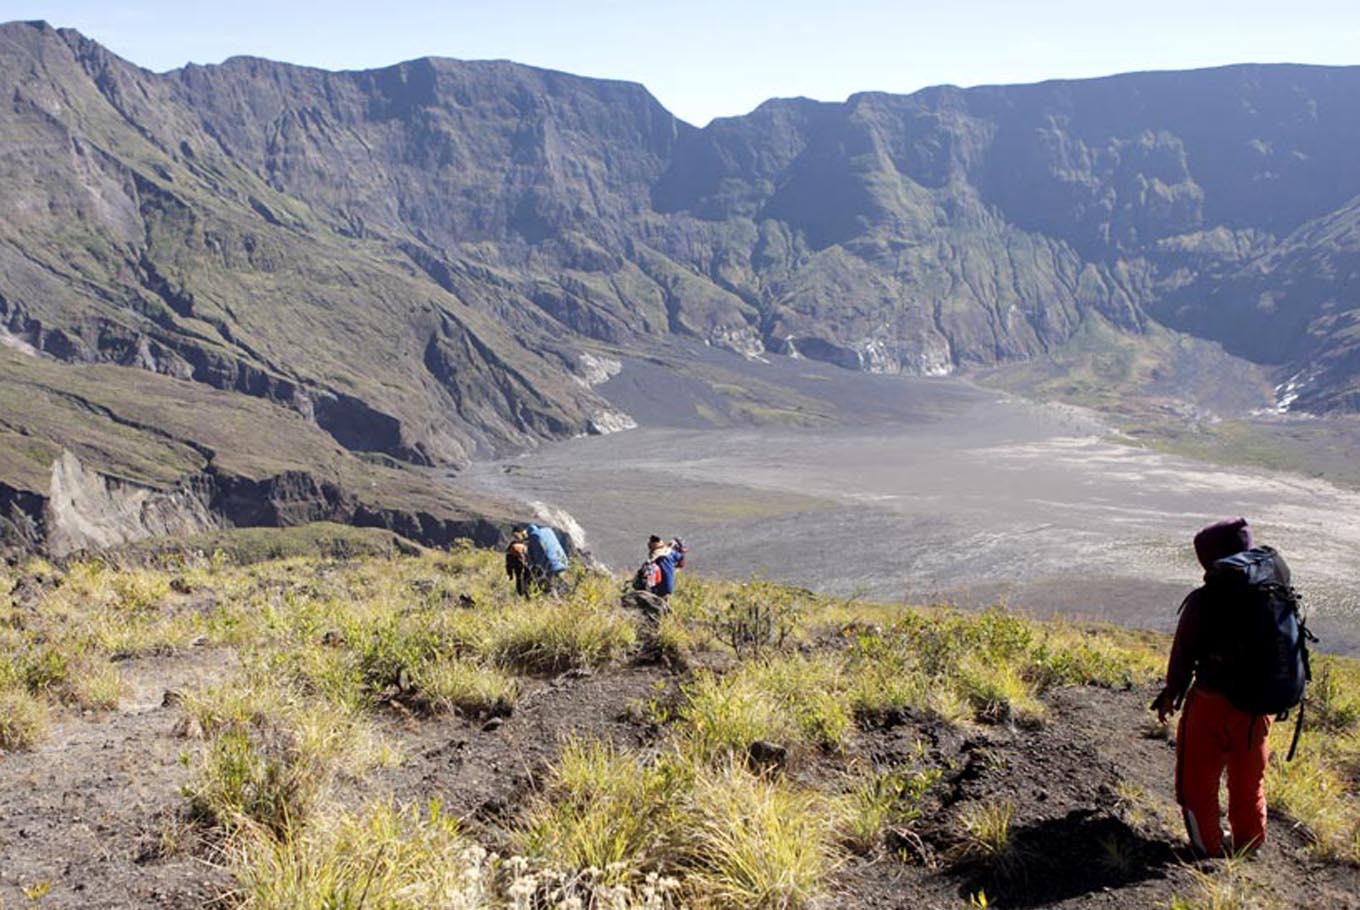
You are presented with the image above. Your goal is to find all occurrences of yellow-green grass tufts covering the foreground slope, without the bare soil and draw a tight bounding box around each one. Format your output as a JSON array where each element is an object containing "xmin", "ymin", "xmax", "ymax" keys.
[{"xmin": 0, "ymin": 527, "xmax": 1360, "ymax": 910}]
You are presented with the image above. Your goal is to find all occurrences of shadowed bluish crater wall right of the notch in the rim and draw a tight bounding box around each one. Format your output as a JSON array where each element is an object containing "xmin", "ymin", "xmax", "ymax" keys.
[{"xmin": 654, "ymin": 67, "xmax": 1360, "ymax": 383}]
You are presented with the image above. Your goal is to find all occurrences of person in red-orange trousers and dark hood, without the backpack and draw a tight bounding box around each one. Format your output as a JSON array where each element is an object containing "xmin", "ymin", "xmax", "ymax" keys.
[{"xmin": 1152, "ymin": 518, "xmax": 1273, "ymax": 857}]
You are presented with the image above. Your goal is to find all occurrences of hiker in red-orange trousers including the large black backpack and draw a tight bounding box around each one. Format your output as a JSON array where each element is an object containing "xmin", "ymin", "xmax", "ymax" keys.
[{"xmin": 1152, "ymin": 518, "xmax": 1316, "ymax": 857}]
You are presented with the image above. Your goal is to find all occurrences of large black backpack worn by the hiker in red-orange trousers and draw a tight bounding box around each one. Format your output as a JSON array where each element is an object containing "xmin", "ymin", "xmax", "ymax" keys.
[{"xmin": 1205, "ymin": 547, "xmax": 1318, "ymax": 754}]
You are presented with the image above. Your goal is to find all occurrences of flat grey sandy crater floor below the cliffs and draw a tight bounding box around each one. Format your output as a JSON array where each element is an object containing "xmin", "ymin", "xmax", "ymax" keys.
[{"xmin": 471, "ymin": 361, "xmax": 1360, "ymax": 653}]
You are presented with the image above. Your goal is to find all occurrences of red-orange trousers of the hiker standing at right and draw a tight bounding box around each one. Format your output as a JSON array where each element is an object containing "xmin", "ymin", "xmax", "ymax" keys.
[{"xmin": 1176, "ymin": 688, "xmax": 1273, "ymax": 856}]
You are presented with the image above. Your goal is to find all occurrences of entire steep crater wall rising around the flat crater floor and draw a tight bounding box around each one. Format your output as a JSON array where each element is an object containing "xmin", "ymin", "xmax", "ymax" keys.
[{"xmin": 0, "ymin": 23, "xmax": 1360, "ymax": 546}]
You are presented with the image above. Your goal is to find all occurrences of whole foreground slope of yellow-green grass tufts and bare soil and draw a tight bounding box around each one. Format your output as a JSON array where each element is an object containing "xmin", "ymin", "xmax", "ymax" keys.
[{"xmin": 0, "ymin": 528, "xmax": 1360, "ymax": 909}]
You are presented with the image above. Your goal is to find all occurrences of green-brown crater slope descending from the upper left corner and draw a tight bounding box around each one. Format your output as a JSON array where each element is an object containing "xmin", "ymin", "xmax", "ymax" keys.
[{"xmin": 0, "ymin": 26, "xmax": 602, "ymax": 464}]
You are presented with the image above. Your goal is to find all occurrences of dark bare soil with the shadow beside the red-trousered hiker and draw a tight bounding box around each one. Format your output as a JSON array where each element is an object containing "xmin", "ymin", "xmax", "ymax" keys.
[{"xmin": 839, "ymin": 688, "xmax": 1360, "ymax": 910}]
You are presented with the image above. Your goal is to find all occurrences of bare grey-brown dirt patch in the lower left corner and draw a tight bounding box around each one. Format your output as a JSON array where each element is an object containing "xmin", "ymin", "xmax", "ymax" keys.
[{"xmin": 0, "ymin": 652, "xmax": 234, "ymax": 907}]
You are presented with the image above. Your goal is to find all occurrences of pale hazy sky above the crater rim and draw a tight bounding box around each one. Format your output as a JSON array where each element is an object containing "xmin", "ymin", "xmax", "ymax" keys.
[{"xmin": 0, "ymin": 0, "xmax": 1360, "ymax": 125}]
